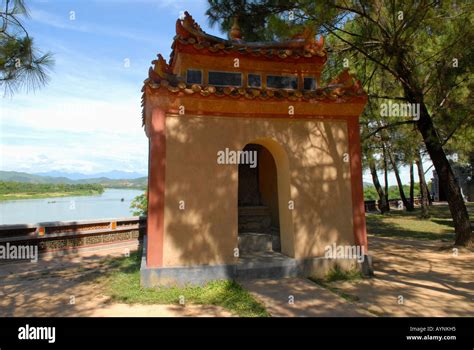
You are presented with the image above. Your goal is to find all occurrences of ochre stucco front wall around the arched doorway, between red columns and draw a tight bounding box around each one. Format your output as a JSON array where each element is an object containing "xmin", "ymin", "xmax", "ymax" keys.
[{"xmin": 160, "ymin": 114, "xmax": 354, "ymax": 266}]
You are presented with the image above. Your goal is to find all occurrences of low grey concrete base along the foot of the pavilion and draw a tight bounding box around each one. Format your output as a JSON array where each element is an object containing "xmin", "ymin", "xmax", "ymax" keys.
[{"xmin": 140, "ymin": 246, "xmax": 370, "ymax": 288}]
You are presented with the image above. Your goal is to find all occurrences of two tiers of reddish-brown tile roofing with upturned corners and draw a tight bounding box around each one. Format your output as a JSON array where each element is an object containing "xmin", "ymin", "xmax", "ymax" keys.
[{"xmin": 142, "ymin": 12, "xmax": 366, "ymax": 123}]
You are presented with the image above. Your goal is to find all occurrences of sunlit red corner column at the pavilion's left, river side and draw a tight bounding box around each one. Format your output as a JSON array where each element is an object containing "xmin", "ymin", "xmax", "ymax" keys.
[{"xmin": 146, "ymin": 108, "xmax": 166, "ymax": 267}]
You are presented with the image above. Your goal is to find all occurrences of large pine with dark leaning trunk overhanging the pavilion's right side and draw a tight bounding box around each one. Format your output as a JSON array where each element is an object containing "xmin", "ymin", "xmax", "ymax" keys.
[{"xmin": 207, "ymin": 0, "xmax": 474, "ymax": 246}]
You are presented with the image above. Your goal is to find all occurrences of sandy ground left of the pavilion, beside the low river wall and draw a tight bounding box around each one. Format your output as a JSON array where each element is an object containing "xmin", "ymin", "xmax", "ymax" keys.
[{"xmin": 0, "ymin": 252, "xmax": 232, "ymax": 317}]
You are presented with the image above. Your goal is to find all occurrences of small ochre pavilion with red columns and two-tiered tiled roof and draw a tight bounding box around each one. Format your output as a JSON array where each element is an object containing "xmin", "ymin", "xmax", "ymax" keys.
[{"xmin": 141, "ymin": 12, "xmax": 368, "ymax": 286}]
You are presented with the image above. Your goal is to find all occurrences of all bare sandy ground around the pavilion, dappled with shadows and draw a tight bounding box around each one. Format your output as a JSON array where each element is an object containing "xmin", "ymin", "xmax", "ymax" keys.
[{"xmin": 0, "ymin": 237, "xmax": 474, "ymax": 317}]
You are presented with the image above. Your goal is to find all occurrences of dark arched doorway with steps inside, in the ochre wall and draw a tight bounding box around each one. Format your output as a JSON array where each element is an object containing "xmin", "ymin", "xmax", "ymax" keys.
[{"xmin": 238, "ymin": 143, "xmax": 281, "ymax": 253}]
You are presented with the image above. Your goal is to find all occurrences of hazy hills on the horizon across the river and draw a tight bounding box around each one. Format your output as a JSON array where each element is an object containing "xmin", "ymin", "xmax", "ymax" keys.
[{"xmin": 0, "ymin": 171, "xmax": 148, "ymax": 189}]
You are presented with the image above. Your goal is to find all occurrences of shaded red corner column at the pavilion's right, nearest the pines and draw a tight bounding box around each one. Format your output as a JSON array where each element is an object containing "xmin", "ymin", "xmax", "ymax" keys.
[{"xmin": 347, "ymin": 117, "xmax": 368, "ymax": 254}]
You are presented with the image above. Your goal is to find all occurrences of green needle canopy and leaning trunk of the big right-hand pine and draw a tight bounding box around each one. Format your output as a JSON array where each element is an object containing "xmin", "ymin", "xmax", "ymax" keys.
[{"xmin": 207, "ymin": 0, "xmax": 474, "ymax": 246}]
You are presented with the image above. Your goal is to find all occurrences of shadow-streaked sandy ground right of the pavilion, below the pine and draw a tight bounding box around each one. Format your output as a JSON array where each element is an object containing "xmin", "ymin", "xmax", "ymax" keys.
[{"xmin": 331, "ymin": 236, "xmax": 474, "ymax": 317}]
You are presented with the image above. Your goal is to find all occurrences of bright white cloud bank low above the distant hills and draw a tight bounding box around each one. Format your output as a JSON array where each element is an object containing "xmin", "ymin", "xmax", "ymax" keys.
[{"xmin": 0, "ymin": 98, "xmax": 148, "ymax": 173}]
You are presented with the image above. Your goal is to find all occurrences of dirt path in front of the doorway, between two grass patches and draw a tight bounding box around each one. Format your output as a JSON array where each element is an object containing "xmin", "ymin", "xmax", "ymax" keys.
[{"xmin": 239, "ymin": 278, "xmax": 373, "ymax": 317}]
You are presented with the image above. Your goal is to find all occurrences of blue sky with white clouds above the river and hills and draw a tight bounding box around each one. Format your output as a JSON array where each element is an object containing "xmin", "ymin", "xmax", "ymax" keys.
[{"xmin": 0, "ymin": 0, "xmax": 426, "ymax": 184}]
